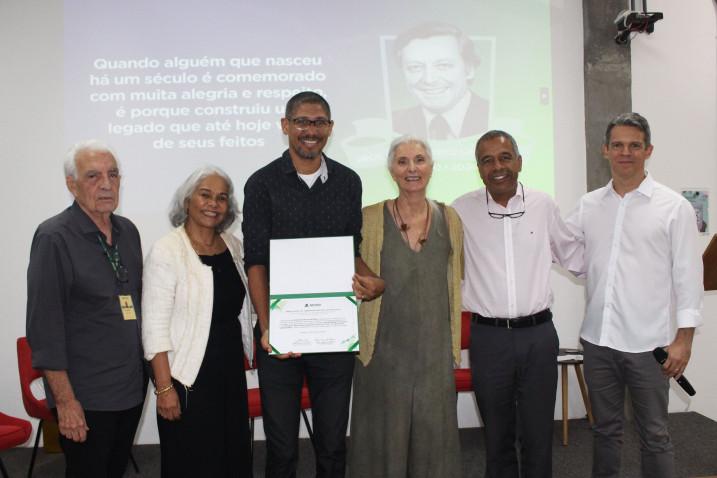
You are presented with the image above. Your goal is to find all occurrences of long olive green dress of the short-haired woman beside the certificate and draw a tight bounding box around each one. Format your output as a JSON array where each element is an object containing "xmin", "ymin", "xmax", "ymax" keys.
[{"xmin": 349, "ymin": 206, "xmax": 461, "ymax": 478}]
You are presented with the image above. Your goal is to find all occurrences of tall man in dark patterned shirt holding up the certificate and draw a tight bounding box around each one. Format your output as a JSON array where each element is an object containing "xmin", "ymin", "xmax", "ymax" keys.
[{"xmin": 242, "ymin": 92, "xmax": 383, "ymax": 478}]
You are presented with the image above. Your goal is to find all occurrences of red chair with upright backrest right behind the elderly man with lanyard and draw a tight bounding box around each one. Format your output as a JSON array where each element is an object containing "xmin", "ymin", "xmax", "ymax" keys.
[{"xmin": 17, "ymin": 337, "xmax": 139, "ymax": 477}]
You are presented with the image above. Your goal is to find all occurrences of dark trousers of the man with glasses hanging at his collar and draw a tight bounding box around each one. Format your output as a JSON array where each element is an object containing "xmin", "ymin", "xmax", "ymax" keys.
[{"xmin": 470, "ymin": 321, "xmax": 559, "ymax": 478}]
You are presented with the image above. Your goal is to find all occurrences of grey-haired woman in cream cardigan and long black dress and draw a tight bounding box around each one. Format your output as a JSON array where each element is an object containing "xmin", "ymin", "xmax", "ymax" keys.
[{"xmin": 142, "ymin": 166, "xmax": 254, "ymax": 478}]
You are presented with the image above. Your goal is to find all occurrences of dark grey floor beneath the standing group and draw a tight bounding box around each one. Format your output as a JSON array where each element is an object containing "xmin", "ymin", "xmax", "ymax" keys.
[{"xmin": 0, "ymin": 413, "xmax": 717, "ymax": 478}]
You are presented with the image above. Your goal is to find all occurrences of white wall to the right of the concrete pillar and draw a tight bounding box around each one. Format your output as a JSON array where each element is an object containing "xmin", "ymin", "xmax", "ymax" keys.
[{"xmin": 631, "ymin": 0, "xmax": 717, "ymax": 420}]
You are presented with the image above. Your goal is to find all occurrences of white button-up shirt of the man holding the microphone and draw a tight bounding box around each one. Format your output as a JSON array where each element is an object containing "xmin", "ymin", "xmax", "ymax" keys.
[{"xmin": 567, "ymin": 174, "xmax": 704, "ymax": 353}]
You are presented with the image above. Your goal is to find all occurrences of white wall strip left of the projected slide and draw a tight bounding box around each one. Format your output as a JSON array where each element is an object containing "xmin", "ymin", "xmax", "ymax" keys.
[{"xmin": 0, "ymin": 1, "xmax": 69, "ymax": 442}]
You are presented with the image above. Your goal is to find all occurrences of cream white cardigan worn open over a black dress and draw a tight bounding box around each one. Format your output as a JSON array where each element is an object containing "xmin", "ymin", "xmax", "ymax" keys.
[{"xmin": 142, "ymin": 226, "xmax": 256, "ymax": 386}]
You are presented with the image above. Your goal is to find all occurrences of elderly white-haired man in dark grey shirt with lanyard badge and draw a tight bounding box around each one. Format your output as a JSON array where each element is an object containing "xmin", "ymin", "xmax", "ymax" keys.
[{"xmin": 27, "ymin": 141, "xmax": 146, "ymax": 478}]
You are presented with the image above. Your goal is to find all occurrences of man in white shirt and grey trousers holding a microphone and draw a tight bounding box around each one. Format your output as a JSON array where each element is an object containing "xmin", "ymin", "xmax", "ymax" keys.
[{"xmin": 567, "ymin": 113, "xmax": 703, "ymax": 478}]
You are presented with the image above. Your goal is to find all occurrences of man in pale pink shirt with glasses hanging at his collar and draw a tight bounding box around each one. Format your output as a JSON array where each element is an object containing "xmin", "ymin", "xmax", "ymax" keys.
[{"xmin": 453, "ymin": 131, "xmax": 582, "ymax": 478}]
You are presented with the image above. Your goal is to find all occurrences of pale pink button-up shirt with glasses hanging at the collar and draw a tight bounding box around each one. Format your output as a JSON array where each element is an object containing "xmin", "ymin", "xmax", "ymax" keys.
[{"xmin": 453, "ymin": 187, "xmax": 582, "ymax": 318}]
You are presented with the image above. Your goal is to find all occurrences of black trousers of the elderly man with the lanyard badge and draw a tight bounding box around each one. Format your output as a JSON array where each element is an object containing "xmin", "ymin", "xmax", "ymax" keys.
[{"xmin": 53, "ymin": 403, "xmax": 144, "ymax": 478}]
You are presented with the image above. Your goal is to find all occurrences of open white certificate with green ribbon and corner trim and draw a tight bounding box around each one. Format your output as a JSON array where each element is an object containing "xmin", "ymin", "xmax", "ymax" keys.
[{"xmin": 269, "ymin": 236, "xmax": 359, "ymax": 354}]
